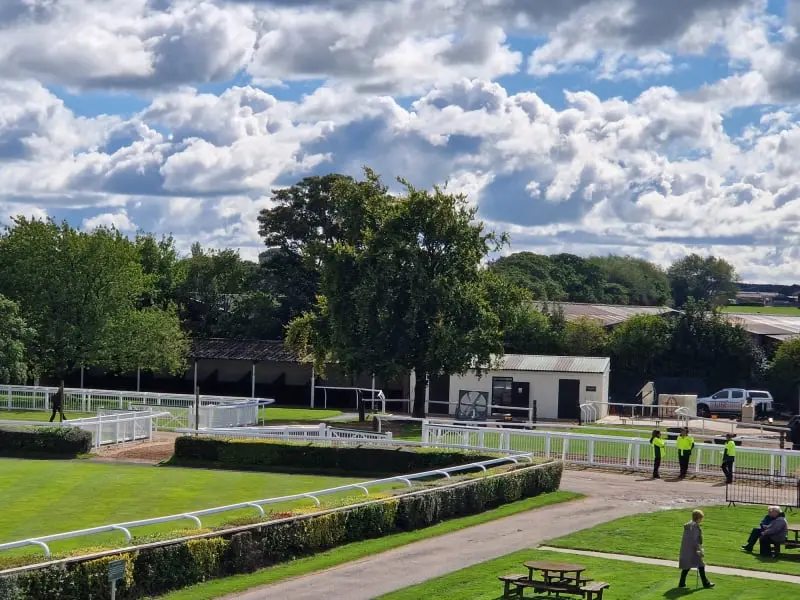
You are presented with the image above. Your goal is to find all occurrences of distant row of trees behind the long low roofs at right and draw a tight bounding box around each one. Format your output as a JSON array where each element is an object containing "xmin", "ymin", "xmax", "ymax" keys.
[{"xmin": 491, "ymin": 252, "xmax": 737, "ymax": 307}]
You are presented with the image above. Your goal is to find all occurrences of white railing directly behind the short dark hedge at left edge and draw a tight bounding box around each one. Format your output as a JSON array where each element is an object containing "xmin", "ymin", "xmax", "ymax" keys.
[{"xmin": 0, "ymin": 410, "xmax": 169, "ymax": 448}]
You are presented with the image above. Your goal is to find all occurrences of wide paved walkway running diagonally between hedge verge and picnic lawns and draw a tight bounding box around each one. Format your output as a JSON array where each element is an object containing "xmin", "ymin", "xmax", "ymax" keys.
[{"xmin": 227, "ymin": 470, "xmax": 724, "ymax": 600}]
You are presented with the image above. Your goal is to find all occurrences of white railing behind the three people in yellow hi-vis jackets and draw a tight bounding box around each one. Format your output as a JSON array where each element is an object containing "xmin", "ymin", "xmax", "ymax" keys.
[{"xmin": 422, "ymin": 424, "xmax": 800, "ymax": 479}]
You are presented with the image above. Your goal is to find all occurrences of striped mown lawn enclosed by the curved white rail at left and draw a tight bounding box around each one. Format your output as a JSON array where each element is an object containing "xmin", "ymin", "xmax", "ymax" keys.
[{"xmin": 0, "ymin": 459, "xmax": 402, "ymax": 559}]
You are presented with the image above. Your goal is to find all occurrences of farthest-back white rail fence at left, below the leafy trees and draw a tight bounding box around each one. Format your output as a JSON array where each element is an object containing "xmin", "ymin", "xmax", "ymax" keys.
[{"xmin": 0, "ymin": 385, "xmax": 275, "ymax": 428}]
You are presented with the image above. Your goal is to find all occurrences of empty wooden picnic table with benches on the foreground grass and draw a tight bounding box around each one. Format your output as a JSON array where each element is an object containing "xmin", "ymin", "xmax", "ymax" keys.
[{"xmin": 498, "ymin": 561, "xmax": 610, "ymax": 600}]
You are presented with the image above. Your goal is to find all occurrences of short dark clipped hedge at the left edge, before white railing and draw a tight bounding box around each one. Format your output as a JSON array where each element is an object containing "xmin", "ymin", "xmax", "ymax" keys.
[{"xmin": 0, "ymin": 427, "xmax": 92, "ymax": 458}]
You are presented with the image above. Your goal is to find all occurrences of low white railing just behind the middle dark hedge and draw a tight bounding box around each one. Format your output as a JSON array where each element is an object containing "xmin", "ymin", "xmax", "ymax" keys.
[{"xmin": 176, "ymin": 423, "xmax": 392, "ymax": 442}]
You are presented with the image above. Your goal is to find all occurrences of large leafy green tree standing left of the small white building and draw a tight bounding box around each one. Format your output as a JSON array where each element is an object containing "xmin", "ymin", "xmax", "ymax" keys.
[{"xmin": 287, "ymin": 171, "xmax": 505, "ymax": 415}]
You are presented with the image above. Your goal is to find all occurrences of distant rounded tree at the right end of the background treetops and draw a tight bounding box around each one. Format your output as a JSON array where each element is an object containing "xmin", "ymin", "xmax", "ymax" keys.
[{"xmin": 667, "ymin": 254, "xmax": 737, "ymax": 307}]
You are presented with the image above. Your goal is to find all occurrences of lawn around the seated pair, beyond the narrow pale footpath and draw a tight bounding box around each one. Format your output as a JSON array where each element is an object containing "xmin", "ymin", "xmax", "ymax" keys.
[{"xmin": 547, "ymin": 506, "xmax": 800, "ymax": 580}]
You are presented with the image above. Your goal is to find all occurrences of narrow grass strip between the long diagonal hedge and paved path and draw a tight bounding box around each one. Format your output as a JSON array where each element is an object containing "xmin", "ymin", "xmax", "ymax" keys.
[{"xmin": 162, "ymin": 492, "xmax": 582, "ymax": 600}]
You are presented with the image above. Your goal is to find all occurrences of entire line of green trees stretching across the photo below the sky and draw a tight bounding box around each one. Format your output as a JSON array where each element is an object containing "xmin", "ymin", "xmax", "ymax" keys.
[{"xmin": 0, "ymin": 169, "xmax": 800, "ymax": 411}]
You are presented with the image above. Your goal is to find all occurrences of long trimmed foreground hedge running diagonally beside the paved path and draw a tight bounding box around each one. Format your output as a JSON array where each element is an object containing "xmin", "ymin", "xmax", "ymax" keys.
[{"xmin": 0, "ymin": 462, "xmax": 562, "ymax": 600}]
